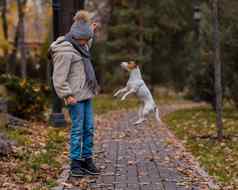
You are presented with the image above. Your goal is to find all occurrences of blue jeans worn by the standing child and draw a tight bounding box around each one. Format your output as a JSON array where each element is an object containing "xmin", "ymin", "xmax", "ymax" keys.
[{"xmin": 69, "ymin": 100, "xmax": 94, "ymax": 160}]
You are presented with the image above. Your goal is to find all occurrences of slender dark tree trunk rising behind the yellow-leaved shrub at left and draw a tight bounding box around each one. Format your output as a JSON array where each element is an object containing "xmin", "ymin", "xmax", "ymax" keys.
[{"xmin": 17, "ymin": 0, "xmax": 27, "ymax": 79}]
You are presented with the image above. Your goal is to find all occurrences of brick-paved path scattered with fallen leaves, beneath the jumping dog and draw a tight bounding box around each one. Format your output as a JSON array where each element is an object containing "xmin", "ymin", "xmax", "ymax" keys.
[{"xmin": 53, "ymin": 106, "xmax": 218, "ymax": 190}]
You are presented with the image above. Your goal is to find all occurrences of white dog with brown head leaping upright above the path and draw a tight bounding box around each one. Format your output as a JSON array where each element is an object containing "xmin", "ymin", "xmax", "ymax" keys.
[{"xmin": 114, "ymin": 61, "xmax": 161, "ymax": 125}]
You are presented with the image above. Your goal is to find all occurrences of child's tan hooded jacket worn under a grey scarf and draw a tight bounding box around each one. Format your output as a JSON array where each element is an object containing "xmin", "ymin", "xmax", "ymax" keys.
[{"xmin": 50, "ymin": 37, "xmax": 94, "ymax": 101}]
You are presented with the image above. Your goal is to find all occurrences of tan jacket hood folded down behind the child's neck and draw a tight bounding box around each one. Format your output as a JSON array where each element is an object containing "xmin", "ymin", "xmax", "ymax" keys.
[{"xmin": 49, "ymin": 36, "xmax": 78, "ymax": 53}]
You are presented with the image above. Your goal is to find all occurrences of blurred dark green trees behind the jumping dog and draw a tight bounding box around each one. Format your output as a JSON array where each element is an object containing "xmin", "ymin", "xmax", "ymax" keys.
[{"xmin": 91, "ymin": 0, "xmax": 238, "ymax": 105}]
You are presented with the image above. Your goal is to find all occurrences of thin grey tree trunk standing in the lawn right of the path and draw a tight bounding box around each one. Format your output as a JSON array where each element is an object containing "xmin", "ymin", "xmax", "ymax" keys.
[{"xmin": 212, "ymin": 0, "xmax": 223, "ymax": 140}]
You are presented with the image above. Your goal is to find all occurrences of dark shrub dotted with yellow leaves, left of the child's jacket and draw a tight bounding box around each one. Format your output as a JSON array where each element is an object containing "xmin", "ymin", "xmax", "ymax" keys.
[{"xmin": 0, "ymin": 75, "xmax": 50, "ymax": 119}]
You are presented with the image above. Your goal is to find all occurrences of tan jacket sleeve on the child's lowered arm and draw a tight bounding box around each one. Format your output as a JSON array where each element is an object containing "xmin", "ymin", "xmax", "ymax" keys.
[{"xmin": 53, "ymin": 53, "xmax": 73, "ymax": 99}]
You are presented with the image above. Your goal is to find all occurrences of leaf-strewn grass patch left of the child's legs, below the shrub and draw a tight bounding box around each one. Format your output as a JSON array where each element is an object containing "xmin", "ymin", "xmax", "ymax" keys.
[{"xmin": 0, "ymin": 124, "xmax": 68, "ymax": 190}]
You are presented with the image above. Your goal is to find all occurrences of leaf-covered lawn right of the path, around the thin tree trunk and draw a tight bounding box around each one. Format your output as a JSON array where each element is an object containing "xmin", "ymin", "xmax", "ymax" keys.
[{"xmin": 165, "ymin": 108, "xmax": 238, "ymax": 190}]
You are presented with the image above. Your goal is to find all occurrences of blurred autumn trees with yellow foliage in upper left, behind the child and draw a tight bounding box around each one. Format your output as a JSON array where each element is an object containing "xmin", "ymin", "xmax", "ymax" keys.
[{"xmin": 0, "ymin": 0, "xmax": 51, "ymax": 80}]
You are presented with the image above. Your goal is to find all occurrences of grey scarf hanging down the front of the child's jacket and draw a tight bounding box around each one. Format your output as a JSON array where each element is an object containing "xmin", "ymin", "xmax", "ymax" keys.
[{"xmin": 65, "ymin": 33, "xmax": 98, "ymax": 94}]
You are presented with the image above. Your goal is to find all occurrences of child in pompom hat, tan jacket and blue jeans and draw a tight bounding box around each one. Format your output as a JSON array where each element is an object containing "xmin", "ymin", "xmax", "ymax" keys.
[{"xmin": 50, "ymin": 11, "xmax": 99, "ymax": 177}]
